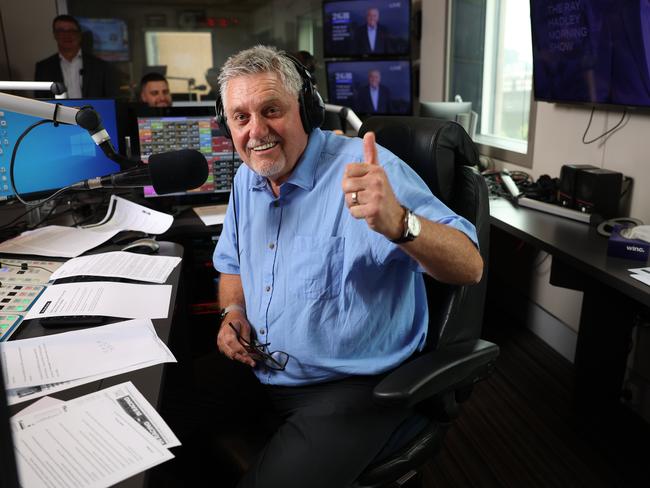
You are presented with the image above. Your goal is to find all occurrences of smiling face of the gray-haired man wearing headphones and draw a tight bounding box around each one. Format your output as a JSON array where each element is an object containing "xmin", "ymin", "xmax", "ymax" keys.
[{"xmin": 224, "ymin": 73, "xmax": 307, "ymax": 185}]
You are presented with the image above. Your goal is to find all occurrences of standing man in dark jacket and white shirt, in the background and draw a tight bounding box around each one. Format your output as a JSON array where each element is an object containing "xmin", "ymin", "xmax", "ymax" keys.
[{"xmin": 34, "ymin": 15, "xmax": 117, "ymax": 98}]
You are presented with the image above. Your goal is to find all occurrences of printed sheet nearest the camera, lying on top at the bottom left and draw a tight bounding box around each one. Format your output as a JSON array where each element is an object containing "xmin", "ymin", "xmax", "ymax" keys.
[{"xmin": 14, "ymin": 395, "xmax": 174, "ymax": 488}]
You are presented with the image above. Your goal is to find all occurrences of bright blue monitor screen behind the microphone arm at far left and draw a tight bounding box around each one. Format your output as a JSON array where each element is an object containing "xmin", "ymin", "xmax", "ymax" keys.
[{"xmin": 0, "ymin": 99, "xmax": 120, "ymax": 201}]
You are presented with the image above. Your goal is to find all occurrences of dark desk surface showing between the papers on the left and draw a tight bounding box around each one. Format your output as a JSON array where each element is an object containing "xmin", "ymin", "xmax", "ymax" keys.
[{"xmin": 5, "ymin": 242, "xmax": 183, "ymax": 488}]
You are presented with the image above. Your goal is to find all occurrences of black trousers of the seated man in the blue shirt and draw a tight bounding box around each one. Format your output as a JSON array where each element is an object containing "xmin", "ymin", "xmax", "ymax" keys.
[{"xmin": 165, "ymin": 353, "xmax": 411, "ymax": 488}]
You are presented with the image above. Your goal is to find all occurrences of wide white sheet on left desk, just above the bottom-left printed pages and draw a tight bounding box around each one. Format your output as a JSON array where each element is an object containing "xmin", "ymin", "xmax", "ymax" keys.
[{"xmin": 0, "ymin": 320, "xmax": 175, "ymax": 389}]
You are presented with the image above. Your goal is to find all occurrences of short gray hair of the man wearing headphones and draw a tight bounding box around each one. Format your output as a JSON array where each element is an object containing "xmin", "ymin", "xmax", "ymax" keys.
[{"xmin": 219, "ymin": 44, "xmax": 302, "ymax": 105}]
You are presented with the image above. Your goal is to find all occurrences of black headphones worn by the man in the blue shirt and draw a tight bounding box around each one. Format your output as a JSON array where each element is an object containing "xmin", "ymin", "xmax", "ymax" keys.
[{"xmin": 216, "ymin": 53, "xmax": 325, "ymax": 139}]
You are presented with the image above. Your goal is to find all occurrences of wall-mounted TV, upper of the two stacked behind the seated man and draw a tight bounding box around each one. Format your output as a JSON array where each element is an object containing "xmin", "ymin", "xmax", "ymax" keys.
[{"xmin": 323, "ymin": 0, "xmax": 411, "ymax": 57}]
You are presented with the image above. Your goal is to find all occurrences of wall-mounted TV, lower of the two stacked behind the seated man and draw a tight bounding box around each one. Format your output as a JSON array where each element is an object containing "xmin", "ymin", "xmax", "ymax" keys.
[{"xmin": 327, "ymin": 60, "xmax": 412, "ymax": 115}]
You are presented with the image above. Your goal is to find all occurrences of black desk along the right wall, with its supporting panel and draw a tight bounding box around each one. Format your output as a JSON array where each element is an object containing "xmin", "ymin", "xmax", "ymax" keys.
[{"xmin": 490, "ymin": 198, "xmax": 650, "ymax": 417}]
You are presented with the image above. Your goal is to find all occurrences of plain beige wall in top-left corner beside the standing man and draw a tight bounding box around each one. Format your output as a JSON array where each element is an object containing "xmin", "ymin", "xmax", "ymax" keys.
[{"xmin": 0, "ymin": 0, "xmax": 58, "ymax": 80}]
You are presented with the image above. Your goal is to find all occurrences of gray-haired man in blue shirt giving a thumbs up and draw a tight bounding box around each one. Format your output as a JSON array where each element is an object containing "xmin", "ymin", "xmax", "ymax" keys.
[{"xmin": 214, "ymin": 46, "xmax": 483, "ymax": 488}]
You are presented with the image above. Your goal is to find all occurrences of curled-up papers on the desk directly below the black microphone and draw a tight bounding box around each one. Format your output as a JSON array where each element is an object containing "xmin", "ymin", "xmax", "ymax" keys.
[{"xmin": 0, "ymin": 195, "xmax": 174, "ymax": 258}]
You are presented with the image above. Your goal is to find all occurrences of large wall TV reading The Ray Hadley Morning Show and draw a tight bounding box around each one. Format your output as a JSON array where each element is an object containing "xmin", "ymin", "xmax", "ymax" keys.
[{"xmin": 530, "ymin": 0, "xmax": 650, "ymax": 107}]
